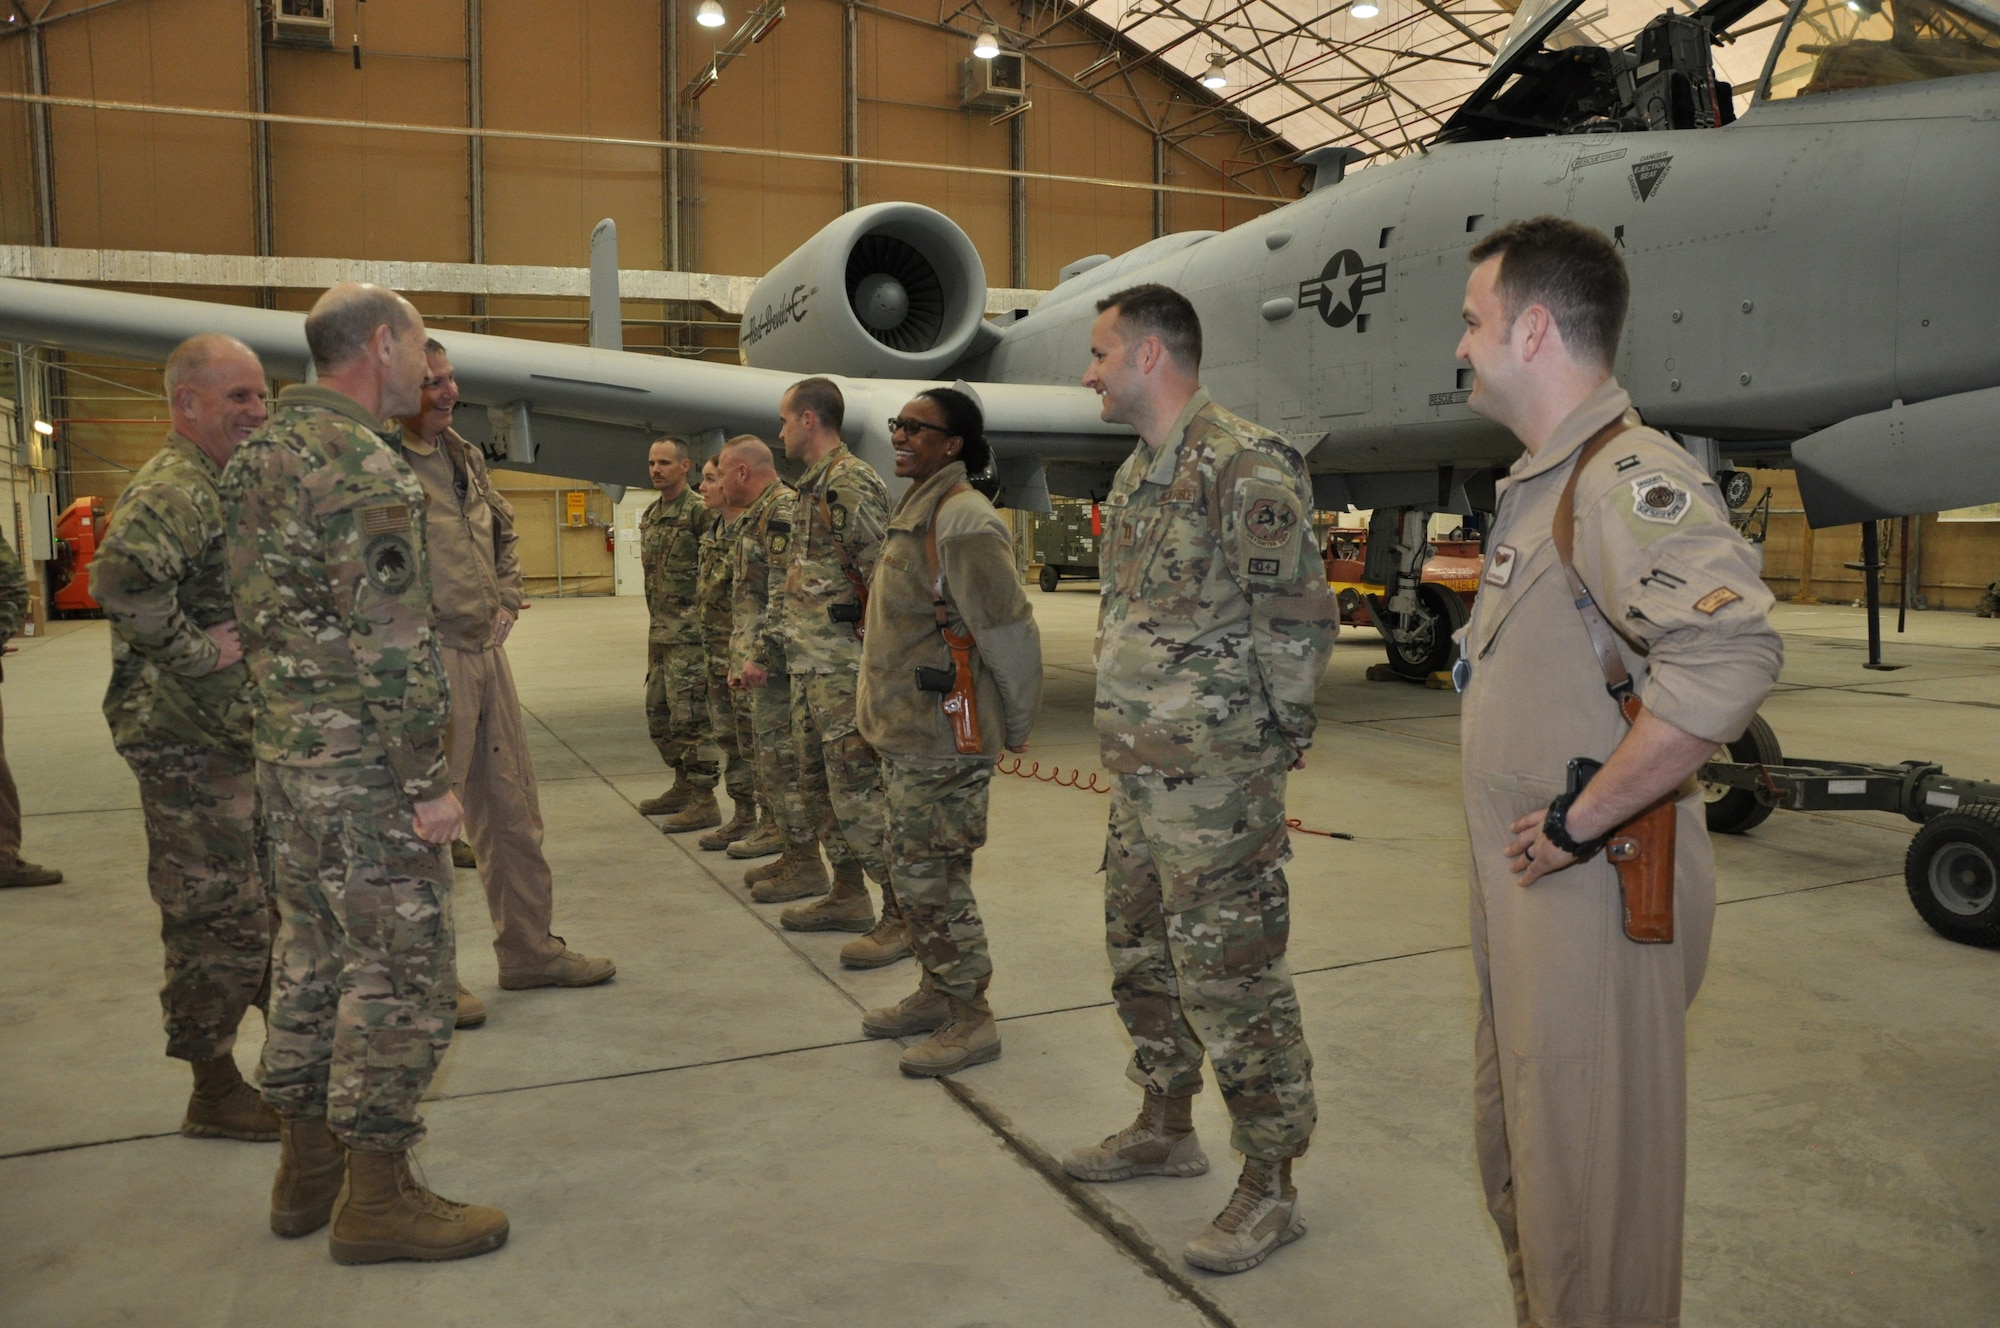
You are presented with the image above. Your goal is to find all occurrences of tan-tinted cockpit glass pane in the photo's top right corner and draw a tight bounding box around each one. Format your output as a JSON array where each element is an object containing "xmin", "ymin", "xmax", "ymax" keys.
[{"xmin": 1758, "ymin": 0, "xmax": 2000, "ymax": 102}]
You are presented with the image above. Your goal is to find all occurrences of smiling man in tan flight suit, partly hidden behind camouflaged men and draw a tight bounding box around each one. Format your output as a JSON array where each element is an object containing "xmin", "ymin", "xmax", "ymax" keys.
[{"xmin": 400, "ymin": 340, "xmax": 618, "ymax": 1028}]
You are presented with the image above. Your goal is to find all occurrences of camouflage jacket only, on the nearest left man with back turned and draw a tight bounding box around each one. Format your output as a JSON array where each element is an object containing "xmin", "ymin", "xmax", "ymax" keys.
[{"xmin": 222, "ymin": 386, "xmax": 452, "ymax": 802}]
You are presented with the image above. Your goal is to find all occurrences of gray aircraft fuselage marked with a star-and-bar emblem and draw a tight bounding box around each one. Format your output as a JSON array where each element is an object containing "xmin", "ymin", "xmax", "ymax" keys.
[{"xmin": 980, "ymin": 76, "xmax": 2000, "ymax": 506}]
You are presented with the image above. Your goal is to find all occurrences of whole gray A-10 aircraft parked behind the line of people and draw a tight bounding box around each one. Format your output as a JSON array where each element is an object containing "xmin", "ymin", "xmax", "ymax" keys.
[{"xmin": 0, "ymin": 0, "xmax": 2000, "ymax": 674}]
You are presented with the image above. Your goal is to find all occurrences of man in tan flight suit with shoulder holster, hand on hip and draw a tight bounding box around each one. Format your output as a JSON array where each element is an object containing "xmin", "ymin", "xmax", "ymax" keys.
[{"xmin": 1458, "ymin": 218, "xmax": 1782, "ymax": 1328}]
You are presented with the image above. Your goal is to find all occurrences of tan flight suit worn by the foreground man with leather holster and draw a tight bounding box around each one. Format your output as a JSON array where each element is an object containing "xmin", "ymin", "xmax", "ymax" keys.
[{"xmin": 1462, "ymin": 380, "xmax": 1784, "ymax": 1328}]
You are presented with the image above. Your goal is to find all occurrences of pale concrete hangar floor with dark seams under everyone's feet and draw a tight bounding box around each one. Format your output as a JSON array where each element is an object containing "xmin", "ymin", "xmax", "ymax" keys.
[{"xmin": 0, "ymin": 586, "xmax": 2000, "ymax": 1328}]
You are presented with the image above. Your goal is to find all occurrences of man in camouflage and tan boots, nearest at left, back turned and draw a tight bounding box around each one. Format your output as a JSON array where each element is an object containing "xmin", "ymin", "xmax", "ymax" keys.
[{"xmin": 222, "ymin": 282, "xmax": 508, "ymax": 1264}]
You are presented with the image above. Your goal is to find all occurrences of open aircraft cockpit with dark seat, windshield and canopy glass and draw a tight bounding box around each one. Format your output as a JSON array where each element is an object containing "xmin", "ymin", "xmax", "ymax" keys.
[{"xmin": 1436, "ymin": 0, "xmax": 2000, "ymax": 142}]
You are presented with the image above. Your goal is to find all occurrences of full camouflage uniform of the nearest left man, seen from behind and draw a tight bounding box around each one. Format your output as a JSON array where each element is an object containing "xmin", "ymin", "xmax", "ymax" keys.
[{"xmin": 222, "ymin": 386, "xmax": 458, "ymax": 1152}]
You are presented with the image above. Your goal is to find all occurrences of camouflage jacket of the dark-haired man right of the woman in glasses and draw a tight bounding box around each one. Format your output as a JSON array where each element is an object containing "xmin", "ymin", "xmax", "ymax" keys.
[{"xmin": 1096, "ymin": 392, "xmax": 1340, "ymax": 776}]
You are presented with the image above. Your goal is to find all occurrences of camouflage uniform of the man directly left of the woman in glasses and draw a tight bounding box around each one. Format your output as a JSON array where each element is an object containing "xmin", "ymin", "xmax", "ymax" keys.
[{"xmin": 784, "ymin": 444, "xmax": 890, "ymax": 896}]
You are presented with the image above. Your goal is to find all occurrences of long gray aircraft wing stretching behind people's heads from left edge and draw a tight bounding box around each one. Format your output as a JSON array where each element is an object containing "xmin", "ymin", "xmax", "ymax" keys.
[{"xmin": 0, "ymin": 278, "xmax": 1132, "ymax": 510}]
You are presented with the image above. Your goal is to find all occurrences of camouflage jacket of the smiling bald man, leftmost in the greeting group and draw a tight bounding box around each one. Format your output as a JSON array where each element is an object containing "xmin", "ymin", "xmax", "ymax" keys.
[{"xmin": 90, "ymin": 434, "xmax": 252, "ymax": 758}]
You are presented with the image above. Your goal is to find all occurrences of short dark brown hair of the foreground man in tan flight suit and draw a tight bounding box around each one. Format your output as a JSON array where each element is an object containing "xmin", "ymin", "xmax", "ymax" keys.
[{"xmin": 1470, "ymin": 216, "xmax": 1632, "ymax": 368}]
